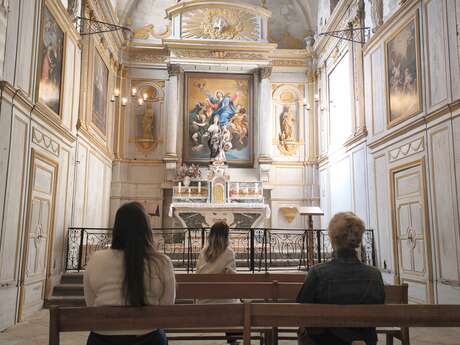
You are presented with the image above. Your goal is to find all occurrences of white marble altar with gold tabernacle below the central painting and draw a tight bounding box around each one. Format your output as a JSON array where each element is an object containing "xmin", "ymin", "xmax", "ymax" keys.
[{"xmin": 169, "ymin": 165, "xmax": 271, "ymax": 228}]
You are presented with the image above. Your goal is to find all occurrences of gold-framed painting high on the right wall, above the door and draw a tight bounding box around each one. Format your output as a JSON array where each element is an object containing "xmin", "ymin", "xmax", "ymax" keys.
[{"xmin": 385, "ymin": 16, "xmax": 422, "ymax": 127}]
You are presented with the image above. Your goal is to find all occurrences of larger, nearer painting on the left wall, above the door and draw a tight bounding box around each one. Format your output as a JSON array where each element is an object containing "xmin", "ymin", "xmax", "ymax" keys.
[{"xmin": 38, "ymin": 7, "xmax": 65, "ymax": 115}]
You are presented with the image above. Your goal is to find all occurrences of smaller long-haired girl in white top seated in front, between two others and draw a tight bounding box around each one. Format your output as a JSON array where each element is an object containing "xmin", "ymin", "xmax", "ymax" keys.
[{"xmin": 196, "ymin": 222, "xmax": 241, "ymax": 345}]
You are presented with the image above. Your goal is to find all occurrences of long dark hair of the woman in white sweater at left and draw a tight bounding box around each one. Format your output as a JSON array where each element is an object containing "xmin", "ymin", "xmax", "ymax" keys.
[{"xmin": 112, "ymin": 202, "xmax": 155, "ymax": 307}]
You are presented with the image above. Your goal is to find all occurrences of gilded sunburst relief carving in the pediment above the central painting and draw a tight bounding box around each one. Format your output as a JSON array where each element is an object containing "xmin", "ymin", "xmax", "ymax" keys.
[{"xmin": 182, "ymin": 8, "xmax": 260, "ymax": 41}]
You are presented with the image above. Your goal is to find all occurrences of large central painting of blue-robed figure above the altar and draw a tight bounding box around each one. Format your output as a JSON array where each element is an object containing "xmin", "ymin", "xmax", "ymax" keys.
[{"xmin": 184, "ymin": 73, "xmax": 253, "ymax": 165}]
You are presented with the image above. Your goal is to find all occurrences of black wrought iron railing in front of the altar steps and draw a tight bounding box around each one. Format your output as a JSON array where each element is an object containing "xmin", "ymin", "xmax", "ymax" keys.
[{"xmin": 65, "ymin": 227, "xmax": 375, "ymax": 272}]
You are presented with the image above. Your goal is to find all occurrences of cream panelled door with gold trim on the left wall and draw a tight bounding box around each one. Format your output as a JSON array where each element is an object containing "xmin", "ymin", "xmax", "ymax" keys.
[{"xmin": 19, "ymin": 151, "xmax": 58, "ymax": 320}]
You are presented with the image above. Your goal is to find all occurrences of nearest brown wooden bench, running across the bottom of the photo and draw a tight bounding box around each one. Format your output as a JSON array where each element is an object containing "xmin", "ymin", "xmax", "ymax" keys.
[{"xmin": 49, "ymin": 303, "xmax": 460, "ymax": 345}]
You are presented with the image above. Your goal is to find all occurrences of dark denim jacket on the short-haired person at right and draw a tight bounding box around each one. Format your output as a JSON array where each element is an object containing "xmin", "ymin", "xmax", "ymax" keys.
[{"xmin": 297, "ymin": 249, "xmax": 385, "ymax": 345}]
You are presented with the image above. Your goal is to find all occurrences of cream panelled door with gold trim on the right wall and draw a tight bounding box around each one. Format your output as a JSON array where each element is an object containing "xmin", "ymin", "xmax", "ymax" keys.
[{"xmin": 391, "ymin": 161, "xmax": 433, "ymax": 303}]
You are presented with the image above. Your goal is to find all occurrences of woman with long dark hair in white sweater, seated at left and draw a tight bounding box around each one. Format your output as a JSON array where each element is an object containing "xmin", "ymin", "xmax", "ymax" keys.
[{"xmin": 84, "ymin": 202, "xmax": 176, "ymax": 345}]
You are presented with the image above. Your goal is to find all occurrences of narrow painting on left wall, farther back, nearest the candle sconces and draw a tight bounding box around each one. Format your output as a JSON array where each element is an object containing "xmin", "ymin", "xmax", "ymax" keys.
[{"xmin": 92, "ymin": 51, "xmax": 109, "ymax": 135}]
